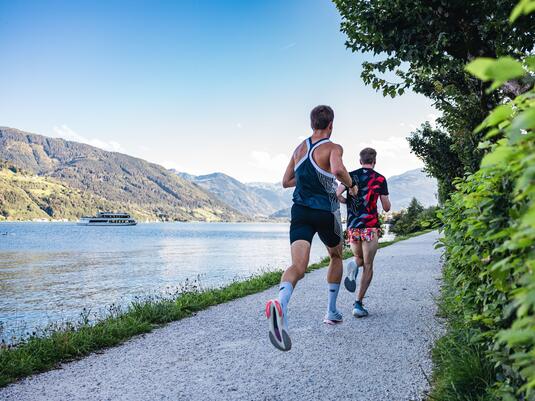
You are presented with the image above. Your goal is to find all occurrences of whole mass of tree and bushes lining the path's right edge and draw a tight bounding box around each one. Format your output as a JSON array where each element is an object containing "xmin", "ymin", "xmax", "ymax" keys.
[{"xmin": 334, "ymin": 0, "xmax": 535, "ymax": 401}]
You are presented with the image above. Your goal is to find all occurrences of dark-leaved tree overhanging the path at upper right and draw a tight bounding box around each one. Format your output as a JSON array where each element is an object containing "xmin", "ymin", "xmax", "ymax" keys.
[{"xmin": 333, "ymin": 0, "xmax": 535, "ymax": 197}]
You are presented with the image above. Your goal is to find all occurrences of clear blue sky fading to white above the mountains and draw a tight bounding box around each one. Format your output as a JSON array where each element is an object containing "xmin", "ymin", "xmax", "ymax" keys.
[{"xmin": 0, "ymin": 0, "xmax": 436, "ymax": 182}]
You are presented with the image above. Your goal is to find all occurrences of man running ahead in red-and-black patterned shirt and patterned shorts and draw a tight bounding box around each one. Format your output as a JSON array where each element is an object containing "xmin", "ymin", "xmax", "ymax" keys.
[{"xmin": 337, "ymin": 148, "xmax": 390, "ymax": 317}]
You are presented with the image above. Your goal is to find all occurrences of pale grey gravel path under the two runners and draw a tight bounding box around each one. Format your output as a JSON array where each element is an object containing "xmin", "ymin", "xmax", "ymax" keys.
[{"xmin": 0, "ymin": 233, "xmax": 441, "ymax": 401}]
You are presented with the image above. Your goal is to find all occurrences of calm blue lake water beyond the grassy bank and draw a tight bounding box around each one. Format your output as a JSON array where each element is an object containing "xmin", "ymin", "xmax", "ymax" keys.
[{"xmin": 0, "ymin": 223, "xmax": 327, "ymax": 340}]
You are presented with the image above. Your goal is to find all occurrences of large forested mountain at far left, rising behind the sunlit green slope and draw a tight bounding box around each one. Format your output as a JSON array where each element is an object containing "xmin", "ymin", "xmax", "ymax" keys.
[{"xmin": 0, "ymin": 127, "xmax": 246, "ymax": 221}]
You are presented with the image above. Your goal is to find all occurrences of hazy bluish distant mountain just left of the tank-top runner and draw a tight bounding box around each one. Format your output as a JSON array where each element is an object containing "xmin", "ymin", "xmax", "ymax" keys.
[{"xmin": 177, "ymin": 173, "xmax": 291, "ymax": 218}]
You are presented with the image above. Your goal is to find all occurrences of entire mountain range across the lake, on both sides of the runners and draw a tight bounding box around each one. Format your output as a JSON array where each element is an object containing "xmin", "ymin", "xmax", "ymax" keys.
[{"xmin": 0, "ymin": 127, "xmax": 438, "ymax": 221}]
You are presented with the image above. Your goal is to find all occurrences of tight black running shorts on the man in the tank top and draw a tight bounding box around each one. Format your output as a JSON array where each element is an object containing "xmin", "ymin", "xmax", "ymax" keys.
[{"xmin": 290, "ymin": 203, "xmax": 342, "ymax": 248}]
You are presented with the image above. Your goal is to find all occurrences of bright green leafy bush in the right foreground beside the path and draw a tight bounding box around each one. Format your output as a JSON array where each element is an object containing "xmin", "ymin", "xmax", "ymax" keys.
[{"xmin": 431, "ymin": 12, "xmax": 535, "ymax": 400}]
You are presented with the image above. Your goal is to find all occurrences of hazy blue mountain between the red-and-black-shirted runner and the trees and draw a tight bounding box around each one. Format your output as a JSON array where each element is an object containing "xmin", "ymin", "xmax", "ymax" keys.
[{"xmin": 387, "ymin": 169, "xmax": 438, "ymax": 211}]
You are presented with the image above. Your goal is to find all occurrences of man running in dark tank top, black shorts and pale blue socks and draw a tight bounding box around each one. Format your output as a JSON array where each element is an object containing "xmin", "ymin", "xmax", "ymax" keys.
[{"xmin": 266, "ymin": 106, "xmax": 357, "ymax": 351}]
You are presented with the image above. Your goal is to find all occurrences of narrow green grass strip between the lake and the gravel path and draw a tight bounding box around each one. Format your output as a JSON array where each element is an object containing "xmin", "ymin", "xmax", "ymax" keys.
[{"xmin": 0, "ymin": 230, "xmax": 431, "ymax": 387}]
